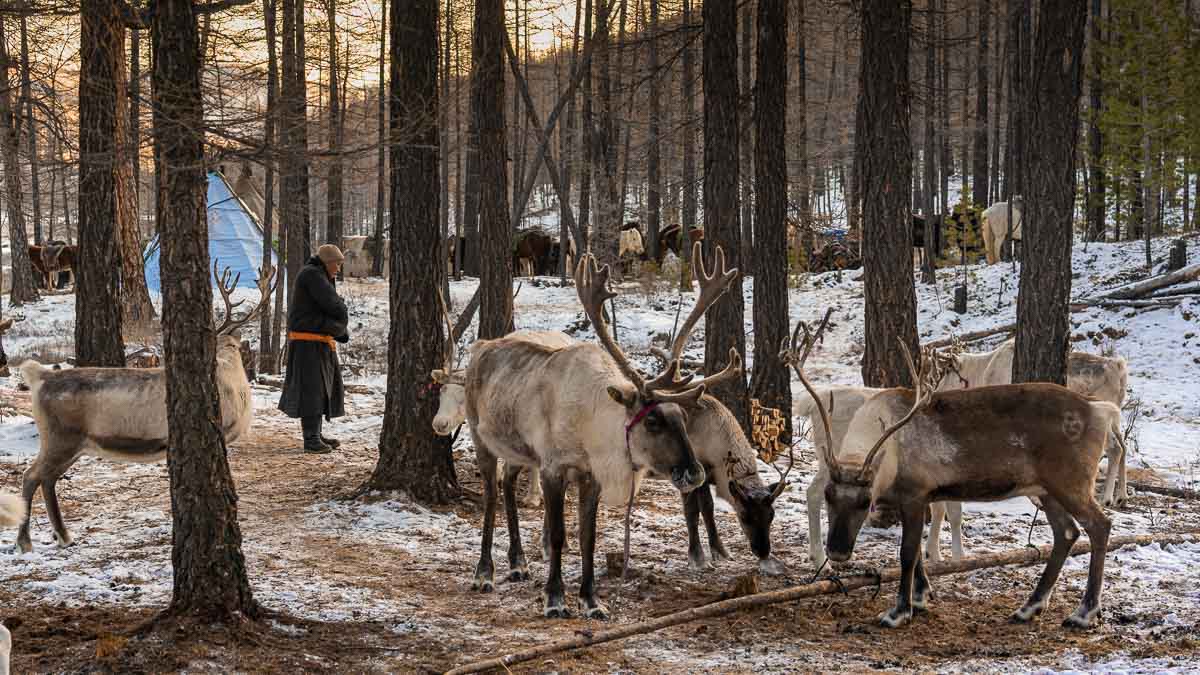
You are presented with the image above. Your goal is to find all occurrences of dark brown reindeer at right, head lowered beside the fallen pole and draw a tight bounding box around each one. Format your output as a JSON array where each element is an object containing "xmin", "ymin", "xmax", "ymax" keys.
[{"xmin": 793, "ymin": 342, "xmax": 1121, "ymax": 628}]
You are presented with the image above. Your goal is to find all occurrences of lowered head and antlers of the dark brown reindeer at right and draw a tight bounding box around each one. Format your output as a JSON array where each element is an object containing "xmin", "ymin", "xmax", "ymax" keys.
[{"xmin": 780, "ymin": 325, "xmax": 943, "ymax": 562}]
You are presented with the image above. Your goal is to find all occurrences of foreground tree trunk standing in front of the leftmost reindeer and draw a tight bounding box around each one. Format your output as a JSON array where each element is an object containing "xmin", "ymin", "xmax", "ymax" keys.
[{"xmin": 152, "ymin": 0, "xmax": 258, "ymax": 622}]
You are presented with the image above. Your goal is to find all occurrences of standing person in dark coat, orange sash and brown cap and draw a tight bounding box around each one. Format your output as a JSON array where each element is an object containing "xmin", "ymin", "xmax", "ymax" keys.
[{"xmin": 280, "ymin": 244, "xmax": 350, "ymax": 454}]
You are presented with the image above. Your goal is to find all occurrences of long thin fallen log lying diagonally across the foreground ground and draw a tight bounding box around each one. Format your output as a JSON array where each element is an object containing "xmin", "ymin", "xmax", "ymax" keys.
[{"xmin": 446, "ymin": 532, "xmax": 1200, "ymax": 675}]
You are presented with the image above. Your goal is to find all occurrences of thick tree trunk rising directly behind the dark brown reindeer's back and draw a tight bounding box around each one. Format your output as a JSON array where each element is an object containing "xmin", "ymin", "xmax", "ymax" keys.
[{"xmin": 1013, "ymin": 0, "xmax": 1087, "ymax": 384}]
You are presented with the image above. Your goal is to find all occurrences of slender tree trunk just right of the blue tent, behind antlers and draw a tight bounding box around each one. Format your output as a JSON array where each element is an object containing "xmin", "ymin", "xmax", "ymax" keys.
[{"xmin": 258, "ymin": 0, "xmax": 277, "ymax": 374}]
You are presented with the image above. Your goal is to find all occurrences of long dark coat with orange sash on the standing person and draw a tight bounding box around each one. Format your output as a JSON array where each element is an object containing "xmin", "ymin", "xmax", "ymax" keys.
[{"xmin": 280, "ymin": 256, "xmax": 349, "ymax": 419}]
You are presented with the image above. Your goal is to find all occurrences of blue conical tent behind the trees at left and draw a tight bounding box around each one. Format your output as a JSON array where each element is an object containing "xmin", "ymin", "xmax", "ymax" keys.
[{"xmin": 145, "ymin": 171, "xmax": 278, "ymax": 293}]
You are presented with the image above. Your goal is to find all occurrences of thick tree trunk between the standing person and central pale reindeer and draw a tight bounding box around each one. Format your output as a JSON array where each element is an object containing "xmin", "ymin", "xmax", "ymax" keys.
[{"xmin": 364, "ymin": 0, "xmax": 456, "ymax": 504}]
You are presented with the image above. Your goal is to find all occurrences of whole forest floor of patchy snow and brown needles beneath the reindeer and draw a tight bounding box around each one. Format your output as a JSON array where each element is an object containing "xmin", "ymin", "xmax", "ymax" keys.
[{"xmin": 0, "ymin": 234, "xmax": 1200, "ymax": 673}]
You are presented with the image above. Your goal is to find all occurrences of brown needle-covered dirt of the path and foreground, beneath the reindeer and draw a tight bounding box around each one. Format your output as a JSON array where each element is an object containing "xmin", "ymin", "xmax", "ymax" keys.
[{"xmin": 0, "ymin": 374, "xmax": 1200, "ymax": 673}]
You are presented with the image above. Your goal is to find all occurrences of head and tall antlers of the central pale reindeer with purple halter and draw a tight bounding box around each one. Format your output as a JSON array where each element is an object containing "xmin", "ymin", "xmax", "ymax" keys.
[{"xmin": 575, "ymin": 244, "xmax": 742, "ymax": 492}]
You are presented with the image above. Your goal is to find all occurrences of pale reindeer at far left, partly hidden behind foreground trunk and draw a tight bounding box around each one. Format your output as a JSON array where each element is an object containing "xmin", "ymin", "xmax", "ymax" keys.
[{"xmin": 17, "ymin": 263, "xmax": 275, "ymax": 552}]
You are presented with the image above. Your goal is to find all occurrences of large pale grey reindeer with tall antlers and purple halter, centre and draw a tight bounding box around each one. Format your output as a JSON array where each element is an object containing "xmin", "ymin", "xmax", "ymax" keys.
[{"xmin": 466, "ymin": 243, "xmax": 737, "ymax": 619}]
